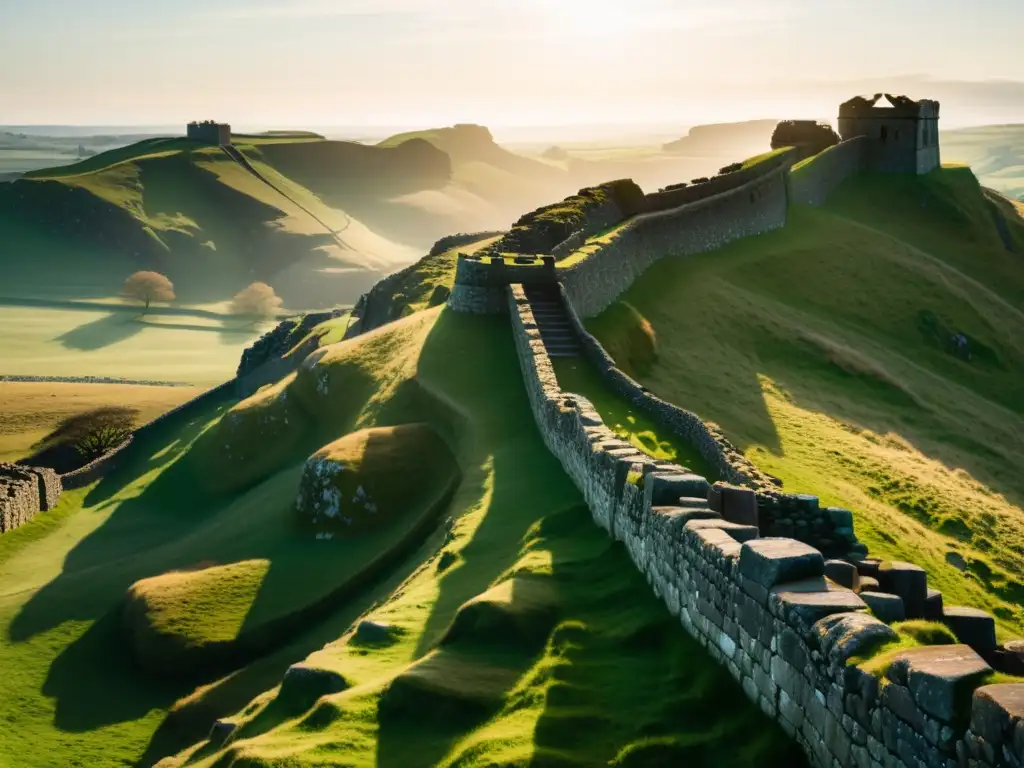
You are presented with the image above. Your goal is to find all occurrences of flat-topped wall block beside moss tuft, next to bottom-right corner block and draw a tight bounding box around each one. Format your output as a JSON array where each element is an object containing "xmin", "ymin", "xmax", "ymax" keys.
[{"xmin": 887, "ymin": 645, "xmax": 992, "ymax": 723}]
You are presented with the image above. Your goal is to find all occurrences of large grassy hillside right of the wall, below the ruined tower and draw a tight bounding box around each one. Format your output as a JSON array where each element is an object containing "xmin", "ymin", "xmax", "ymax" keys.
[{"xmin": 591, "ymin": 168, "xmax": 1024, "ymax": 633}]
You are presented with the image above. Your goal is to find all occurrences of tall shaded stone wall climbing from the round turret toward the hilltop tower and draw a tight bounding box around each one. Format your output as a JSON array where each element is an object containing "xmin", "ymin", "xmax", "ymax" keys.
[{"xmin": 558, "ymin": 158, "xmax": 787, "ymax": 317}]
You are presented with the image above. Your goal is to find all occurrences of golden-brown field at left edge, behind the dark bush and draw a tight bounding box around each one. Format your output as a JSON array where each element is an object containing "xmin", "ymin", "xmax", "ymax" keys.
[{"xmin": 0, "ymin": 382, "xmax": 203, "ymax": 462}]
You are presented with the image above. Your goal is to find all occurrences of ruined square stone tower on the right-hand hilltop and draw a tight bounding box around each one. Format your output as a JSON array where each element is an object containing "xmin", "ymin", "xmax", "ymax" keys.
[{"xmin": 839, "ymin": 93, "xmax": 940, "ymax": 175}]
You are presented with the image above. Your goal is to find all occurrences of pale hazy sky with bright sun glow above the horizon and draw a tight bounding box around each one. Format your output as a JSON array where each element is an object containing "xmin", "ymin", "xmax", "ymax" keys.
[{"xmin": 0, "ymin": 0, "xmax": 1024, "ymax": 127}]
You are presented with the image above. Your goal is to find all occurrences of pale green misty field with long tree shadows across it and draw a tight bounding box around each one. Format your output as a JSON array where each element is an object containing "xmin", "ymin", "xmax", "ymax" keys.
[{"xmin": 0, "ymin": 306, "xmax": 263, "ymax": 385}]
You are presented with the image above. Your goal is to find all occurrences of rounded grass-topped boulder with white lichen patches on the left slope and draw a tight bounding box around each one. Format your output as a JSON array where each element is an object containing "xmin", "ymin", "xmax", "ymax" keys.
[{"xmin": 296, "ymin": 424, "xmax": 459, "ymax": 538}]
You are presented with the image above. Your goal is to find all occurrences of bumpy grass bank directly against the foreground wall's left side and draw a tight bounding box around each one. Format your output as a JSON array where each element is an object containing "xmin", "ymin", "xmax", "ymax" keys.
[{"xmin": 157, "ymin": 311, "xmax": 803, "ymax": 766}]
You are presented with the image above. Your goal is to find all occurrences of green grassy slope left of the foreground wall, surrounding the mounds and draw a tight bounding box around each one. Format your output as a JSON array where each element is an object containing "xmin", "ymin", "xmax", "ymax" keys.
[{"xmin": 0, "ymin": 309, "xmax": 800, "ymax": 768}]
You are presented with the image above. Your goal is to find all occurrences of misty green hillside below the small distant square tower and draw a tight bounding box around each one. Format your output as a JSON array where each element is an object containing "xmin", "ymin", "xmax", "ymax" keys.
[{"xmin": 0, "ymin": 137, "xmax": 450, "ymax": 307}]
